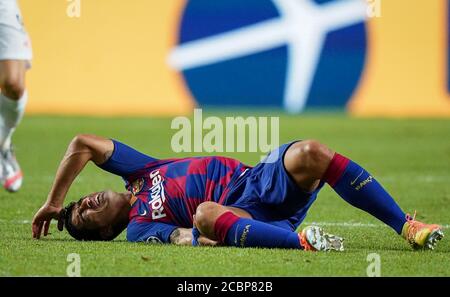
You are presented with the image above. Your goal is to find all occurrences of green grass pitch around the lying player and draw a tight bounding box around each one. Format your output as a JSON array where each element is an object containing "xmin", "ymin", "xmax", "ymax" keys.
[{"xmin": 0, "ymin": 114, "xmax": 450, "ymax": 276}]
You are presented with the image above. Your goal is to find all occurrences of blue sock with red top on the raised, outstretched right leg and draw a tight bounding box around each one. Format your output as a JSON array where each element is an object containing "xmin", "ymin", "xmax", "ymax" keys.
[{"xmin": 323, "ymin": 153, "xmax": 406, "ymax": 234}]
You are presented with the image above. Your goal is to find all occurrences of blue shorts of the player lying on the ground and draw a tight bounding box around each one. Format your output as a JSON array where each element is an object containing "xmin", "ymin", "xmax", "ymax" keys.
[{"xmin": 228, "ymin": 142, "xmax": 324, "ymax": 231}]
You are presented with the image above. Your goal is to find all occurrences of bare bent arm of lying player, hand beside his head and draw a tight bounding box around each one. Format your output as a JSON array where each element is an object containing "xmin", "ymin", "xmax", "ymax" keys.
[{"xmin": 32, "ymin": 135, "xmax": 114, "ymax": 239}]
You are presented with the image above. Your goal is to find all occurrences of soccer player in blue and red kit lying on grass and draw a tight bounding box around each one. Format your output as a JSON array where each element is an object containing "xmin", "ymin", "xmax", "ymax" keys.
[{"xmin": 32, "ymin": 135, "xmax": 443, "ymax": 251}]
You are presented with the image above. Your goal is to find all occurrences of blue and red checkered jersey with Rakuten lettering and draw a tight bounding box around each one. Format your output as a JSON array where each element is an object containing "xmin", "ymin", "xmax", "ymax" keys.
[{"xmin": 100, "ymin": 140, "xmax": 250, "ymax": 242}]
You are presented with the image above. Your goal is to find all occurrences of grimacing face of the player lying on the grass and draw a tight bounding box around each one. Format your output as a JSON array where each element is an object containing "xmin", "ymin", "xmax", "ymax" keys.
[{"xmin": 72, "ymin": 190, "xmax": 130, "ymax": 230}]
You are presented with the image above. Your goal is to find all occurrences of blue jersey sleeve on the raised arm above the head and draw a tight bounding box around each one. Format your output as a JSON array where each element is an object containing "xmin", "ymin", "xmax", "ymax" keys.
[{"xmin": 99, "ymin": 140, "xmax": 158, "ymax": 178}]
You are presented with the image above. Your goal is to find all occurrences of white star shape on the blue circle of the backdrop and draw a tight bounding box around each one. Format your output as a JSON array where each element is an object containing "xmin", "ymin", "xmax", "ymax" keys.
[{"xmin": 168, "ymin": 0, "xmax": 367, "ymax": 112}]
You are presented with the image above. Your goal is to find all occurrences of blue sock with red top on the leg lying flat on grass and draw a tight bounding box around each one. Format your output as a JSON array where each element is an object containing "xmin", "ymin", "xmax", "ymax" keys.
[{"xmin": 214, "ymin": 212, "xmax": 302, "ymax": 249}]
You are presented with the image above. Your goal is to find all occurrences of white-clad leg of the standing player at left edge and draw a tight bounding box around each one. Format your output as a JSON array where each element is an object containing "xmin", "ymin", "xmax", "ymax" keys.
[{"xmin": 0, "ymin": 0, "xmax": 32, "ymax": 192}]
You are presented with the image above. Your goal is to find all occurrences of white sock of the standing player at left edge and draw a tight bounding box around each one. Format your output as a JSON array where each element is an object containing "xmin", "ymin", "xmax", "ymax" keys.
[{"xmin": 0, "ymin": 91, "xmax": 28, "ymax": 151}]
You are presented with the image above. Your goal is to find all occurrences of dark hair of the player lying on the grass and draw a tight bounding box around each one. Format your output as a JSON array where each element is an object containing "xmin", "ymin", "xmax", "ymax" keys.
[{"xmin": 61, "ymin": 199, "xmax": 126, "ymax": 241}]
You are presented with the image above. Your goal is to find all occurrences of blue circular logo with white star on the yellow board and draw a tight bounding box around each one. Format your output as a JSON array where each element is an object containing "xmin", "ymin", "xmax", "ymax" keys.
[{"xmin": 169, "ymin": 0, "xmax": 367, "ymax": 112}]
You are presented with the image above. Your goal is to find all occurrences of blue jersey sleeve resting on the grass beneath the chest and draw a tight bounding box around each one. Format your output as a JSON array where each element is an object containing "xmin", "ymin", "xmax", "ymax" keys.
[{"xmin": 127, "ymin": 220, "xmax": 178, "ymax": 243}]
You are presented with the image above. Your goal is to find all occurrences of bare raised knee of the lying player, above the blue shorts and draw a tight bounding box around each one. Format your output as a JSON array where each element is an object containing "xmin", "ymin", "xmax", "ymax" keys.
[{"xmin": 290, "ymin": 140, "xmax": 333, "ymax": 170}]
